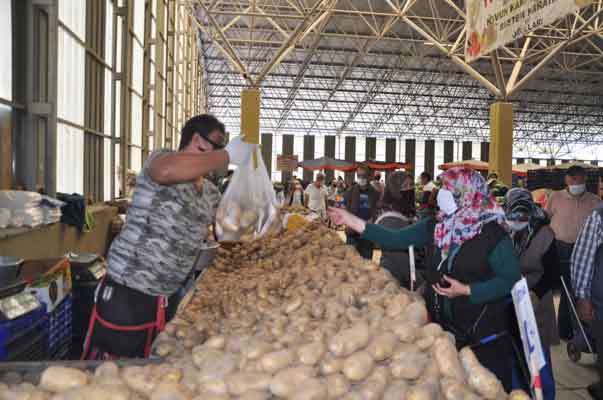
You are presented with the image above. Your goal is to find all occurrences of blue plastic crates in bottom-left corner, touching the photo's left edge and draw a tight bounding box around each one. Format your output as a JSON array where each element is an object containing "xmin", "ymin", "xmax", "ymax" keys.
[{"xmin": 0, "ymin": 304, "xmax": 48, "ymax": 361}]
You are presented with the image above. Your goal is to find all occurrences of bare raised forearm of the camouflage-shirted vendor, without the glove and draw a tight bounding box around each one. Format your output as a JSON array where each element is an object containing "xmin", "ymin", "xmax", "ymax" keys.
[{"xmin": 149, "ymin": 150, "xmax": 229, "ymax": 185}]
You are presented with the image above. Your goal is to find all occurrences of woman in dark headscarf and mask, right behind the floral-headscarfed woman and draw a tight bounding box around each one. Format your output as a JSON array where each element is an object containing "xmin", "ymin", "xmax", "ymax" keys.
[{"xmin": 505, "ymin": 188, "xmax": 559, "ymax": 400}]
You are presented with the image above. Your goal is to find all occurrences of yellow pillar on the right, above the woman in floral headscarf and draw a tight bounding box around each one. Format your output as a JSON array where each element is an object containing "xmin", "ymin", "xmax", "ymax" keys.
[{"xmin": 490, "ymin": 102, "xmax": 513, "ymax": 186}]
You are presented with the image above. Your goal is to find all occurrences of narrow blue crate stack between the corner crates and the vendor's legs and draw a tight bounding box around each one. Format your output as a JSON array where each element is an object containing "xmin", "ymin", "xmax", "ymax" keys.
[{"xmin": 47, "ymin": 294, "xmax": 73, "ymax": 360}]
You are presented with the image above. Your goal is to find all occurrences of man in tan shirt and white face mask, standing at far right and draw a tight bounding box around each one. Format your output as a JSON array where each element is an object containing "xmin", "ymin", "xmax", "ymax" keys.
[{"xmin": 546, "ymin": 166, "xmax": 603, "ymax": 340}]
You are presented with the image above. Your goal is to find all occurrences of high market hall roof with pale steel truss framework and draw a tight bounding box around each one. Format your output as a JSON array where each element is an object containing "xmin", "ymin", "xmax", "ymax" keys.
[{"xmin": 189, "ymin": 0, "xmax": 603, "ymax": 144}]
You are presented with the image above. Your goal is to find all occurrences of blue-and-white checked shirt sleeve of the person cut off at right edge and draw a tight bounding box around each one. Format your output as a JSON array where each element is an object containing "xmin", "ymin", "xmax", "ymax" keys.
[{"xmin": 571, "ymin": 211, "xmax": 602, "ymax": 300}]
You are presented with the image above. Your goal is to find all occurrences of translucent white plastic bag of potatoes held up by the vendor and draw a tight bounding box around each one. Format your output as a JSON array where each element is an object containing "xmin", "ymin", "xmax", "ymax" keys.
[{"xmin": 216, "ymin": 149, "xmax": 280, "ymax": 241}]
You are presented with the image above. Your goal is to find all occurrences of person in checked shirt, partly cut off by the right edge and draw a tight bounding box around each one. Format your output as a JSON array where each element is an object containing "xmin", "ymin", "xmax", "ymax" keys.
[{"xmin": 571, "ymin": 209, "xmax": 603, "ymax": 400}]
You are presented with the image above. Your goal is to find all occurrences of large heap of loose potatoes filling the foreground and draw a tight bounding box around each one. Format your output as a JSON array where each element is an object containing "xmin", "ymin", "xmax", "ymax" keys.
[{"xmin": 0, "ymin": 224, "xmax": 529, "ymax": 400}]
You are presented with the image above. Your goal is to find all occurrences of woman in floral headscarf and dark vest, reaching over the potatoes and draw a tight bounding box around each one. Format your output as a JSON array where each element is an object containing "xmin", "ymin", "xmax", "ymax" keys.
[{"xmin": 329, "ymin": 168, "xmax": 520, "ymax": 390}]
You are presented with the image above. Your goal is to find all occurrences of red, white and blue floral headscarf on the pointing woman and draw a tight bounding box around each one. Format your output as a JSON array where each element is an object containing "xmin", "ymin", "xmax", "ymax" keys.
[{"xmin": 435, "ymin": 167, "xmax": 505, "ymax": 259}]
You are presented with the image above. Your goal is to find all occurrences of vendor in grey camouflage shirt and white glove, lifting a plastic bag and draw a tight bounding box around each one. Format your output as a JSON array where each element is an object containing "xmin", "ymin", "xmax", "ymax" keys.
[{"xmin": 82, "ymin": 115, "xmax": 257, "ymax": 359}]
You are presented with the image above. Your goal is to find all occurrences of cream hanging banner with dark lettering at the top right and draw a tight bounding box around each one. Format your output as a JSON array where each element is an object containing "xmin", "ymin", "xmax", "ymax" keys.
[{"xmin": 465, "ymin": 0, "xmax": 593, "ymax": 62}]
